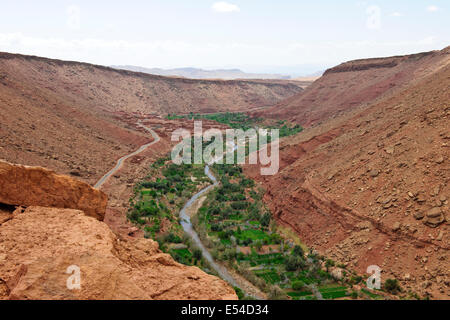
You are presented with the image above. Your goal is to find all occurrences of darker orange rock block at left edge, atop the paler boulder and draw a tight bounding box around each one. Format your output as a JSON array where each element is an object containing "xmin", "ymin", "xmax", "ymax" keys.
[{"xmin": 0, "ymin": 161, "xmax": 108, "ymax": 221}]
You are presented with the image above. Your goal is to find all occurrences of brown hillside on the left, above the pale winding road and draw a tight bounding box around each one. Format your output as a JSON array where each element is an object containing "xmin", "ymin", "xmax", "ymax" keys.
[{"xmin": 0, "ymin": 59, "xmax": 149, "ymax": 184}]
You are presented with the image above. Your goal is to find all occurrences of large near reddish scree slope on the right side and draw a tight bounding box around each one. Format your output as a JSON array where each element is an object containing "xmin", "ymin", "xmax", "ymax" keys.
[{"xmin": 245, "ymin": 63, "xmax": 450, "ymax": 299}]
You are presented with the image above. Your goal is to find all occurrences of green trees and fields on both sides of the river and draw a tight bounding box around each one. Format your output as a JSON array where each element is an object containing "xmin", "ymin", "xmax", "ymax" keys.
[{"xmin": 128, "ymin": 113, "xmax": 400, "ymax": 300}]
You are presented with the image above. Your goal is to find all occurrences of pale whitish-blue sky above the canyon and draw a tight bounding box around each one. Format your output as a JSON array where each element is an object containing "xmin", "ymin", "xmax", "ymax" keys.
[{"xmin": 0, "ymin": 0, "xmax": 450, "ymax": 75}]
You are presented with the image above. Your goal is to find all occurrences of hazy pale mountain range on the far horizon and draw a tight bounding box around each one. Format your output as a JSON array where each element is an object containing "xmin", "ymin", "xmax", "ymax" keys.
[{"xmin": 112, "ymin": 66, "xmax": 291, "ymax": 80}]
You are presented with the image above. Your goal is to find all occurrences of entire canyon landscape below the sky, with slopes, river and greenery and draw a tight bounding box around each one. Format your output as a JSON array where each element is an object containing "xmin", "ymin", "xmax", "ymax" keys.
[{"xmin": 0, "ymin": 47, "xmax": 450, "ymax": 300}]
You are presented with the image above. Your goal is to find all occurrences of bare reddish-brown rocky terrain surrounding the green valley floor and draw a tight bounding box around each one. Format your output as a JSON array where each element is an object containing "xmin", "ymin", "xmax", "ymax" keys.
[{"xmin": 0, "ymin": 48, "xmax": 450, "ymax": 299}]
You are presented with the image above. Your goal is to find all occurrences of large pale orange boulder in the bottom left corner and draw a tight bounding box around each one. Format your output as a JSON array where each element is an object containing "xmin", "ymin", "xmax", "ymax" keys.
[{"xmin": 0, "ymin": 207, "xmax": 237, "ymax": 300}]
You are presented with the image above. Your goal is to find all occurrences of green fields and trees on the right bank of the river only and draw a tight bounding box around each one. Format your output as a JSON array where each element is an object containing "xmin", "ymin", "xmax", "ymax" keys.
[{"xmin": 192, "ymin": 164, "xmax": 348, "ymax": 299}]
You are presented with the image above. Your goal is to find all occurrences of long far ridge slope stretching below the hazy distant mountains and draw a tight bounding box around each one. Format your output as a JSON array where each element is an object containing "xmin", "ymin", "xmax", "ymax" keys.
[{"xmin": 0, "ymin": 53, "xmax": 302, "ymax": 115}]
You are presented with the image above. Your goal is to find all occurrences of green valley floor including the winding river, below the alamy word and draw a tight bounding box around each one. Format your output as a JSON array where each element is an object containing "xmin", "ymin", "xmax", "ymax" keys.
[{"xmin": 125, "ymin": 115, "xmax": 390, "ymax": 300}]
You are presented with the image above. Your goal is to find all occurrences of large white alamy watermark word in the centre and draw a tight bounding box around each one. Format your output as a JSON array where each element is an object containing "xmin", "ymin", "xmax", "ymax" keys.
[{"xmin": 171, "ymin": 121, "xmax": 280, "ymax": 175}]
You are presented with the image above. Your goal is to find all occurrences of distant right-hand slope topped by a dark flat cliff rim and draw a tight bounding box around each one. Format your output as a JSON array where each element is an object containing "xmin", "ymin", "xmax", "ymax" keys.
[{"xmin": 255, "ymin": 47, "xmax": 450, "ymax": 126}]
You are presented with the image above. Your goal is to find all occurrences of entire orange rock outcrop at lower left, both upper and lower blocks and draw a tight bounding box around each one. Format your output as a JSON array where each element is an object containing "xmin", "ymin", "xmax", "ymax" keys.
[{"xmin": 0, "ymin": 162, "xmax": 237, "ymax": 300}]
